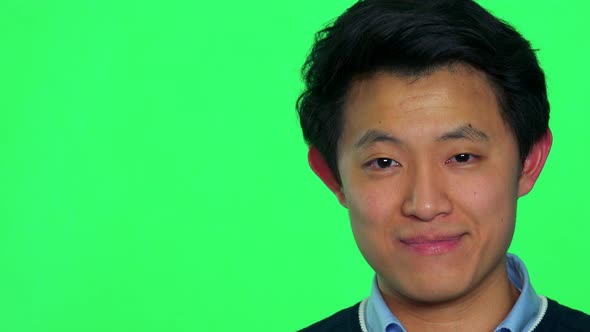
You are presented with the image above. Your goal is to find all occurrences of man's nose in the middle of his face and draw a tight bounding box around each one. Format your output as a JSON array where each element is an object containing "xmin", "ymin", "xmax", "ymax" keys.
[{"xmin": 402, "ymin": 167, "xmax": 452, "ymax": 221}]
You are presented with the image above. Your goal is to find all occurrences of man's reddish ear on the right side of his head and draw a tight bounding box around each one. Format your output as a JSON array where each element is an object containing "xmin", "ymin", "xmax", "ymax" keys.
[{"xmin": 518, "ymin": 129, "xmax": 553, "ymax": 197}]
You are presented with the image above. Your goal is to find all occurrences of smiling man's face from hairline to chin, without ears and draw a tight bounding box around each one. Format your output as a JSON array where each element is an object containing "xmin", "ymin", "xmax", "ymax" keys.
[{"xmin": 338, "ymin": 65, "xmax": 530, "ymax": 303}]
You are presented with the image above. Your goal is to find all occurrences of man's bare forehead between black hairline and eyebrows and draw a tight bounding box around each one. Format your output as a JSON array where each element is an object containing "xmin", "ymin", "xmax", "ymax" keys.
[{"xmin": 341, "ymin": 65, "xmax": 506, "ymax": 147}]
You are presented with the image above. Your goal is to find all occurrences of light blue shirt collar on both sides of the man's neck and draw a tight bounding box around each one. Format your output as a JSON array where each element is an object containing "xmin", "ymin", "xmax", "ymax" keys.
[{"xmin": 365, "ymin": 254, "xmax": 541, "ymax": 332}]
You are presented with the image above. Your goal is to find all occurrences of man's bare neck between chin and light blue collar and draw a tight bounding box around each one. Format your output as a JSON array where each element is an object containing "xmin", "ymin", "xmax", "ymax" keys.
[{"xmin": 381, "ymin": 262, "xmax": 520, "ymax": 332}]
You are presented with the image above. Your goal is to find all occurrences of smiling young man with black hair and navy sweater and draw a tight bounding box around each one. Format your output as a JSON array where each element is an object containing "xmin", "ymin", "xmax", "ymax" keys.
[{"xmin": 297, "ymin": 0, "xmax": 590, "ymax": 332}]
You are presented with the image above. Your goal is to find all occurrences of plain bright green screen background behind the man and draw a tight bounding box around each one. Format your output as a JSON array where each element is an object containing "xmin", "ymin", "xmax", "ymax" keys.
[{"xmin": 0, "ymin": 0, "xmax": 590, "ymax": 332}]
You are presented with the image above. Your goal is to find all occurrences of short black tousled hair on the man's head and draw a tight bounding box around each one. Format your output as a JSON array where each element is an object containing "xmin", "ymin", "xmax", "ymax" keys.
[{"xmin": 297, "ymin": 0, "xmax": 549, "ymax": 178}]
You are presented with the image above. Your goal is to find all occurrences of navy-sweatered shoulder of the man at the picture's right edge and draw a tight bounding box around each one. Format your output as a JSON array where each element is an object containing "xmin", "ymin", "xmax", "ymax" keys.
[{"xmin": 538, "ymin": 298, "xmax": 590, "ymax": 332}]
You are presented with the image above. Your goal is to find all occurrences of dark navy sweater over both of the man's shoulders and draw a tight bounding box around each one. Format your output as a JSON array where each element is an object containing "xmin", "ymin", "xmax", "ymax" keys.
[{"xmin": 300, "ymin": 299, "xmax": 590, "ymax": 332}]
